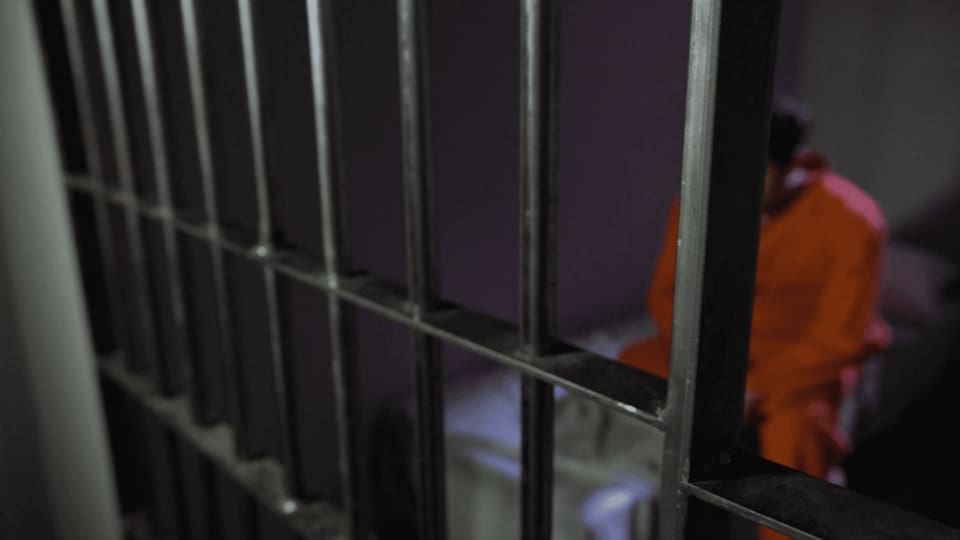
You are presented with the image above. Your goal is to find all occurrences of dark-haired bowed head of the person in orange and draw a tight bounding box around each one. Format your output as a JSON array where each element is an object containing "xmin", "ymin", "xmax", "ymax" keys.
[{"xmin": 763, "ymin": 99, "xmax": 810, "ymax": 207}]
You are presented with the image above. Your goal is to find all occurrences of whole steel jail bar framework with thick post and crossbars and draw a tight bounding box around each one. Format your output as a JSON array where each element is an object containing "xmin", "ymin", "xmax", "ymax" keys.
[{"xmin": 54, "ymin": 0, "xmax": 958, "ymax": 539}]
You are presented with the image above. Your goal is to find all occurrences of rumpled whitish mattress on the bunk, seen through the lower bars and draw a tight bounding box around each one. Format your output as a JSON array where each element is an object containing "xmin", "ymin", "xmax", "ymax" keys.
[{"xmin": 445, "ymin": 314, "xmax": 663, "ymax": 540}]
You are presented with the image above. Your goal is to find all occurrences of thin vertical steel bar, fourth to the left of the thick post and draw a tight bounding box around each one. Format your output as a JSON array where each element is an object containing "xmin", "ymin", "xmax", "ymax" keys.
[{"xmin": 237, "ymin": 0, "xmax": 295, "ymax": 492}]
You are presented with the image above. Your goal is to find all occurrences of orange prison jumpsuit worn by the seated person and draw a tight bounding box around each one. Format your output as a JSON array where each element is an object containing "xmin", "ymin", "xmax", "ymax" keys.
[{"xmin": 620, "ymin": 154, "xmax": 890, "ymax": 538}]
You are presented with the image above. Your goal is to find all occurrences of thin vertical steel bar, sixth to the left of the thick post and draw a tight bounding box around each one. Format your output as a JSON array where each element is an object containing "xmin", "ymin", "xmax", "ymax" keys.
[{"xmin": 131, "ymin": 0, "xmax": 189, "ymax": 392}]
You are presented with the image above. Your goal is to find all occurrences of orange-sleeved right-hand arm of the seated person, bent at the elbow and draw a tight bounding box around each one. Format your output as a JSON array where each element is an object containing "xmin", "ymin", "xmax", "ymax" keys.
[{"xmin": 747, "ymin": 220, "xmax": 885, "ymax": 401}]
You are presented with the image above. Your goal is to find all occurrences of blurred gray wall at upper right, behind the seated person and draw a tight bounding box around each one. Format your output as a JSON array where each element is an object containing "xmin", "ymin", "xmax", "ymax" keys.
[{"xmin": 803, "ymin": 0, "xmax": 960, "ymax": 227}]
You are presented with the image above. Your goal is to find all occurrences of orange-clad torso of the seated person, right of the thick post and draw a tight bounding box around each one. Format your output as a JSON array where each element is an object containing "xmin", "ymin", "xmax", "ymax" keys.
[{"xmin": 747, "ymin": 154, "xmax": 890, "ymax": 414}]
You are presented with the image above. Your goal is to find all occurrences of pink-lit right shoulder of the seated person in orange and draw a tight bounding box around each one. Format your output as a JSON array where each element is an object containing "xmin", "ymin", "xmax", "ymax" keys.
[{"xmin": 818, "ymin": 173, "xmax": 887, "ymax": 236}]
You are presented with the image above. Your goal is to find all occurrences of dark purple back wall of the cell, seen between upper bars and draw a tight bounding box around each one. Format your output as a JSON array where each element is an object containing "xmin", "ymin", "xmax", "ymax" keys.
[{"xmin": 337, "ymin": 0, "xmax": 802, "ymax": 335}]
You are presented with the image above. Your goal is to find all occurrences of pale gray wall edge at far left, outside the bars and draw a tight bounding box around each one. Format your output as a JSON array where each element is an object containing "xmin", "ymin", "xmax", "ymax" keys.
[{"xmin": 0, "ymin": 0, "xmax": 121, "ymax": 540}]
